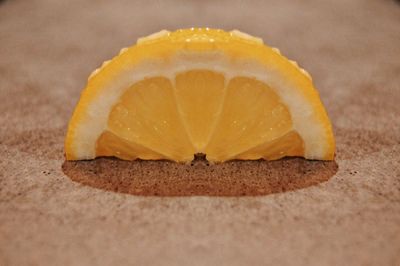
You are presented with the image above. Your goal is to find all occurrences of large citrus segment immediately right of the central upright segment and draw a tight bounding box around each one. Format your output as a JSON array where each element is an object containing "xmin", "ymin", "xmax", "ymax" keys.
[{"xmin": 205, "ymin": 77, "xmax": 292, "ymax": 160}]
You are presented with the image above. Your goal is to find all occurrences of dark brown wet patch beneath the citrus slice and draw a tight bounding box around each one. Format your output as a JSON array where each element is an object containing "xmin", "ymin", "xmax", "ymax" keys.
[{"xmin": 62, "ymin": 158, "xmax": 338, "ymax": 196}]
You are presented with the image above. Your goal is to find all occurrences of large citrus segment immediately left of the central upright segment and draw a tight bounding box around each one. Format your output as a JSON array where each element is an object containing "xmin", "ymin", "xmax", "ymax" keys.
[{"xmin": 98, "ymin": 77, "xmax": 195, "ymax": 161}]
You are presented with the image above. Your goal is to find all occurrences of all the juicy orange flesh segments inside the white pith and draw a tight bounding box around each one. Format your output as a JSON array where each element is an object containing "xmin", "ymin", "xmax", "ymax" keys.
[{"xmin": 96, "ymin": 70, "xmax": 304, "ymax": 161}]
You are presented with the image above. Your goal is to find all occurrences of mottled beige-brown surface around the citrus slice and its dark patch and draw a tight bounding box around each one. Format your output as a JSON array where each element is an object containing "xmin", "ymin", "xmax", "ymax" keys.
[{"xmin": 0, "ymin": 0, "xmax": 400, "ymax": 265}]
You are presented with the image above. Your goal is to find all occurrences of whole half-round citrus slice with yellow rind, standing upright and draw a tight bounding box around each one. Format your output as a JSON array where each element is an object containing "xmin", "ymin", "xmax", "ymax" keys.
[{"xmin": 65, "ymin": 28, "xmax": 335, "ymax": 162}]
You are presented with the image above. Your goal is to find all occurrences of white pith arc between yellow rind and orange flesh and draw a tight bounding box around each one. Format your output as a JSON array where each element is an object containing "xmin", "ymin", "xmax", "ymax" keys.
[{"xmin": 72, "ymin": 52, "xmax": 328, "ymax": 159}]
